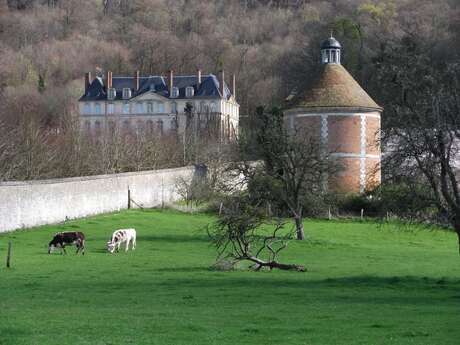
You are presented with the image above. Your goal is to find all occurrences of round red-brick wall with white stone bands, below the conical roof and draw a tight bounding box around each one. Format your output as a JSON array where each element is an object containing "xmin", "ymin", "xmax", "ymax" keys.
[{"xmin": 286, "ymin": 111, "xmax": 381, "ymax": 193}]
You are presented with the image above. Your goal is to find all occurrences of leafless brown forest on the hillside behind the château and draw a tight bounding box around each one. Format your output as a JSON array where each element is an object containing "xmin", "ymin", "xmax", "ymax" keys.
[{"xmin": 0, "ymin": 0, "xmax": 460, "ymax": 180}]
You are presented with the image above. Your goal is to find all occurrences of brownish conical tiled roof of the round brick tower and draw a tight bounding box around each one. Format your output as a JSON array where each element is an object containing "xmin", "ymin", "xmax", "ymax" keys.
[{"xmin": 294, "ymin": 64, "xmax": 382, "ymax": 111}]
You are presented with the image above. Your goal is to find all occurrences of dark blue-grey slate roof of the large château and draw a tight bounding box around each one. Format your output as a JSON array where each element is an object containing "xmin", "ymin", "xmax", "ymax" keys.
[{"xmin": 79, "ymin": 74, "xmax": 231, "ymax": 101}]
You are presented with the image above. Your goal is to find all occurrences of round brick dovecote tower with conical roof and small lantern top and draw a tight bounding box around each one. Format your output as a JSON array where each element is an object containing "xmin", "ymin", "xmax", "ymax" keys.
[{"xmin": 285, "ymin": 36, "xmax": 382, "ymax": 193}]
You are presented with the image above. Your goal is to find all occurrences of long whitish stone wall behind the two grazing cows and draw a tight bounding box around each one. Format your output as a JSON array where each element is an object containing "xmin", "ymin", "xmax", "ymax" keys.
[{"xmin": 0, "ymin": 167, "xmax": 195, "ymax": 232}]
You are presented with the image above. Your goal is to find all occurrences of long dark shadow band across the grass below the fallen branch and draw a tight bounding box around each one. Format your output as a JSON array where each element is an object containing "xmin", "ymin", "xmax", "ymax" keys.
[{"xmin": 32, "ymin": 272, "xmax": 460, "ymax": 308}]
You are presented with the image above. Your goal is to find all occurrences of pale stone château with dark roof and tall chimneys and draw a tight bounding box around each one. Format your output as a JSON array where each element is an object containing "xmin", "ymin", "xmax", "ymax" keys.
[{"xmin": 78, "ymin": 70, "xmax": 239, "ymax": 140}]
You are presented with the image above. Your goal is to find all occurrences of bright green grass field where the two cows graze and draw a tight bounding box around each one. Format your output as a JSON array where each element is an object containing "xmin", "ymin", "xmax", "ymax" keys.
[{"xmin": 0, "ymin": 210, "xmax": 460, "ymax": 345}]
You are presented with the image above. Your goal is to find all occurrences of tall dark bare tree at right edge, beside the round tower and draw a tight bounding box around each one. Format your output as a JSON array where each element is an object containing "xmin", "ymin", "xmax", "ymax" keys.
[{"xmin": 379, "ymin": 35, "xmax": 460, "ymax": 251}]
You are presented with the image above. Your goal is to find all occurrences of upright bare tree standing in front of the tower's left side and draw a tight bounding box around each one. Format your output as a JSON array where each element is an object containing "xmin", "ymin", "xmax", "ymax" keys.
[{"xmin": 239, "ymin": 108, "xmax": 334, "ymax": 240}]
